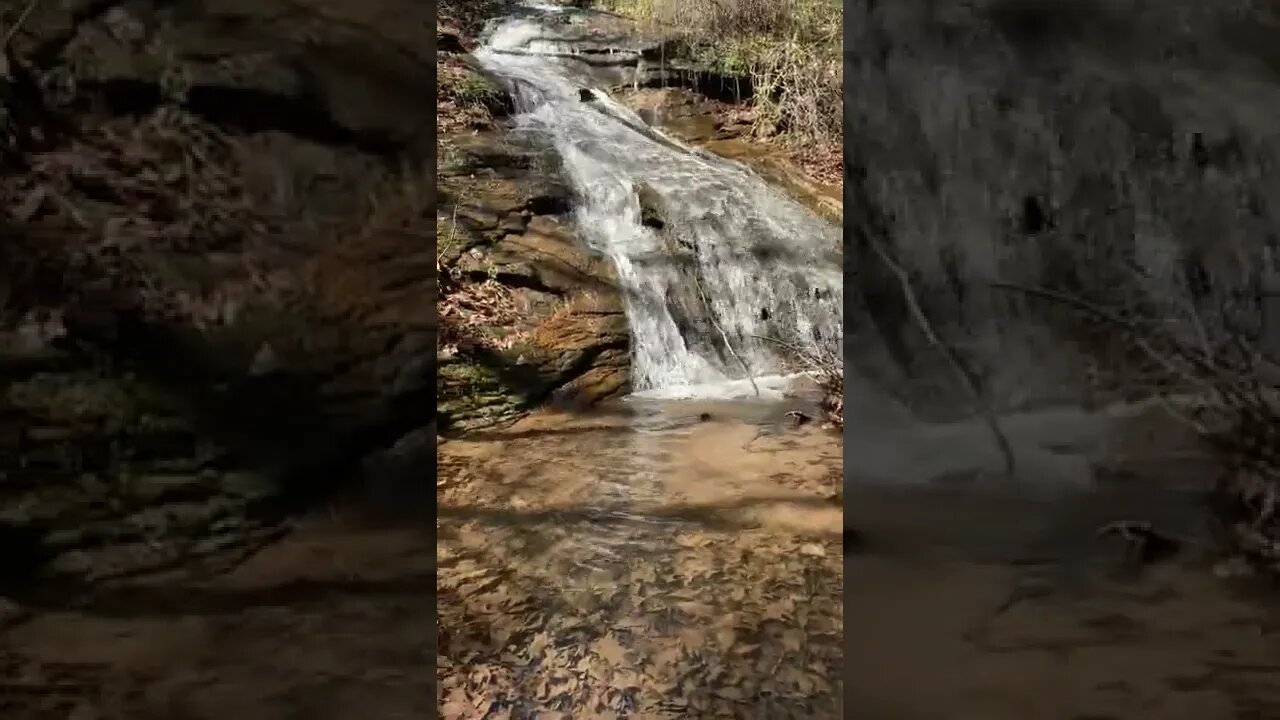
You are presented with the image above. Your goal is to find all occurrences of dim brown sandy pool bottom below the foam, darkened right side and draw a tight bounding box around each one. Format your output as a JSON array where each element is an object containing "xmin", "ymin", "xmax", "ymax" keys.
[{"xmin": 845, "ymin": 488, "xmax": 1280, "ymax": 720}]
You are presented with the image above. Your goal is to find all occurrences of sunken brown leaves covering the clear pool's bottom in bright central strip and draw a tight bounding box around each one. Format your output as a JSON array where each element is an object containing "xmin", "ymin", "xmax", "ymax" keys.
[{"xmin": 436, "ymin": 412, "xmax": 844, "ymax": 720}]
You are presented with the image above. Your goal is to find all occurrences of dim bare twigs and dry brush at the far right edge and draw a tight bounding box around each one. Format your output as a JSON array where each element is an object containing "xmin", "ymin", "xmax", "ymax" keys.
[{"xmin": 998, "ymin": 269, "xmax": 1280, "ymax": 573}]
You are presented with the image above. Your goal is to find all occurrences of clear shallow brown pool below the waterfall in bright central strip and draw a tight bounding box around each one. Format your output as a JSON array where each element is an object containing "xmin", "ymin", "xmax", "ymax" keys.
[{"xmin": 438, "ymin": 404, "xmax": 842, "ymax": 719}]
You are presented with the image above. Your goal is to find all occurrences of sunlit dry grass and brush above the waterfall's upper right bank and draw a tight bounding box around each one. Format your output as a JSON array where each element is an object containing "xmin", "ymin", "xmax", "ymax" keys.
[{"xmin": 604, "ymin": 0, "xmax": 844, "ymax": 179}]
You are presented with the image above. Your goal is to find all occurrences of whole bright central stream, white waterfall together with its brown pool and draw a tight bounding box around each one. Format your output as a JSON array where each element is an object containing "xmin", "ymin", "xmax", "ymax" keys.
[{"xmin": 438, "ymin": 5, "xmax": 844, "ymax": 719}]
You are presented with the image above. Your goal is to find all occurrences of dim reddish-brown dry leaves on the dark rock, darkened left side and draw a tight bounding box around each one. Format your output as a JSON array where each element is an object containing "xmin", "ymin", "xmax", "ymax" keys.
[{"xmin": 0, "ymin": 108, "xmax": 265, "ymax": 327}]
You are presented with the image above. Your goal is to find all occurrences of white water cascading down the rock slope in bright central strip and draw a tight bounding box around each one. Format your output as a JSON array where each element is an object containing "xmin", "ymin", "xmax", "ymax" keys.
[{"xmin": 476, "ymin": 5, "xmax": 844, "ymax": 396}]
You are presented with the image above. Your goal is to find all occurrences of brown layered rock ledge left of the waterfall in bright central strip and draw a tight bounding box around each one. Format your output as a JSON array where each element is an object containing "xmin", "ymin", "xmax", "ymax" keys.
[{"xmin": 438, "ymin": 129, "xmax": 630, "ymax": 430}]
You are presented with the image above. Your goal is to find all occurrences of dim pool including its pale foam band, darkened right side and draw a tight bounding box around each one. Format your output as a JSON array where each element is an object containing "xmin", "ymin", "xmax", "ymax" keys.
[{"xmin": 844, "ymin": 395, "xmax": 1280, "ymax": 720}]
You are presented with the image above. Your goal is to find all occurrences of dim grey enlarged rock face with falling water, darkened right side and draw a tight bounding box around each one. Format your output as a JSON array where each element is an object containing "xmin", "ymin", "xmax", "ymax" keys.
[{"xmin": 845, "ymin": 0, "xmax": 1280, "ymax": 415}]
